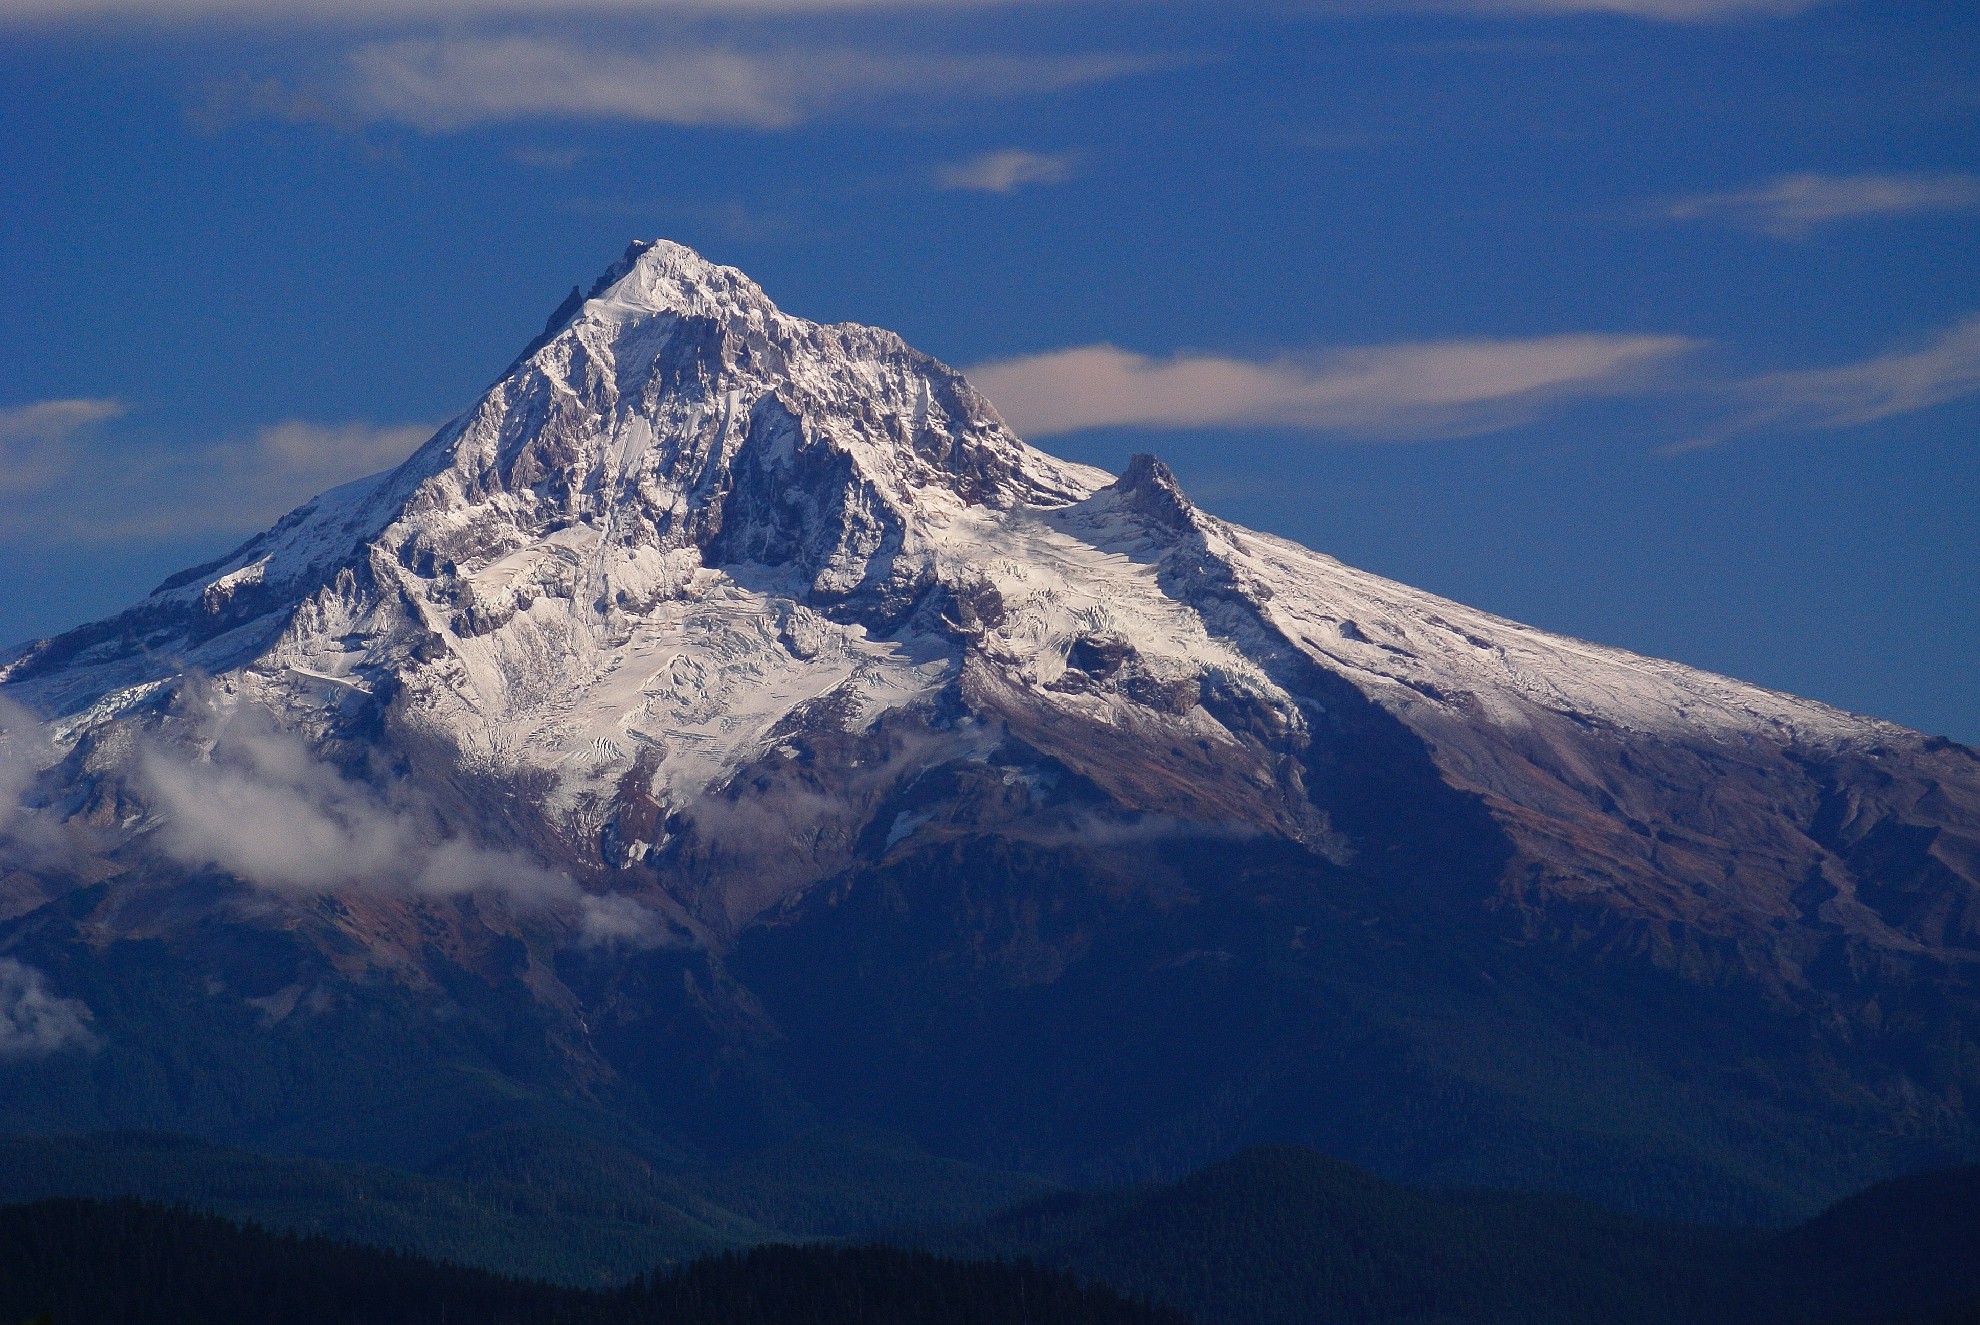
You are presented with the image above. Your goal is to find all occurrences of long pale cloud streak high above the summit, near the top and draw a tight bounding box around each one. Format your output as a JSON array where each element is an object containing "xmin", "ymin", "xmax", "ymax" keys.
[{"xmin": 350, "ymin": 36, "xmax": 1148, "ymax": 131}]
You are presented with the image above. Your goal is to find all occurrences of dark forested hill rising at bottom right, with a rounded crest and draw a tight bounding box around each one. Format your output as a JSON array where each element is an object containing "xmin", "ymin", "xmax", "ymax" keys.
[{"xmin": 897, "ymin": 1147, "xmax": 1980, "ymax": 1325}]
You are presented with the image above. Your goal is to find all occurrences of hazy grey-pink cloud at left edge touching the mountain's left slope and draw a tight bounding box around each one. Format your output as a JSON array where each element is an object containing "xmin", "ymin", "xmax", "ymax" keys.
[{"xmin": 0, "ymin": 400, "xmax": 434, "ymax": 543}]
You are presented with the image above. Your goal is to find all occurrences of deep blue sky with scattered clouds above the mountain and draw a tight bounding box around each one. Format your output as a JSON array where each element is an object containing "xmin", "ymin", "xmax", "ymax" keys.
[{"xmin": 0, "ymin": 0, "xmax": 1980, "ymax": 741}]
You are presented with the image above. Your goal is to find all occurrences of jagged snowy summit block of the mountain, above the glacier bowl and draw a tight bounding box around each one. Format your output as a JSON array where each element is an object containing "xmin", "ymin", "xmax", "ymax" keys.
[{"xmin": 471, "ymin": 240, "xmax": 1105, "ymax": 546}]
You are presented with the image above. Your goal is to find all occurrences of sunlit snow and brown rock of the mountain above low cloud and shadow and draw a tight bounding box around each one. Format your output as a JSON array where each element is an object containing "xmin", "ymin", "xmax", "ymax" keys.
[{"xmin": 0, "ymin": 242, "xmax": 1980, "ymax": 962}]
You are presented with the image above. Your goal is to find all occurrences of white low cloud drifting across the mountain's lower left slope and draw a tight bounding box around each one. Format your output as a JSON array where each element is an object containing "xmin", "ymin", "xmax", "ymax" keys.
[{"xmin": 137, "ymin": 707, "xmax": 665, "ymax": 943}]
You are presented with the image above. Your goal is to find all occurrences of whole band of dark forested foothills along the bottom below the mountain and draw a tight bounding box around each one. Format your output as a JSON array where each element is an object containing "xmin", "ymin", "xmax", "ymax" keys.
[{"xmin": 0, "ymin": 1133, "xmax": 1980, "ymax": 1325}]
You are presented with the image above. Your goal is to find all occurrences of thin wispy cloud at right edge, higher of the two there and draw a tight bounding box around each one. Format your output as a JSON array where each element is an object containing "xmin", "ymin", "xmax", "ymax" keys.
[{"xmin": 1659, "ymin": 172, "xmax": 1980, "ymax": 240}]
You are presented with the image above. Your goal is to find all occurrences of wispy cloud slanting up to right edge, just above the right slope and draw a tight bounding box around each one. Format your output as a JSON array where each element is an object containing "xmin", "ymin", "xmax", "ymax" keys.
[{"xmin": 1667, "ymin": 313, "xmax": 1980, "ymax": 452}]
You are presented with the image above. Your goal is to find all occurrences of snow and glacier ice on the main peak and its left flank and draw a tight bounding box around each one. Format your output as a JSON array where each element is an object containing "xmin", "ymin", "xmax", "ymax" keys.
[{"xmin": 4, "ymin": 244, "xmax": 1107, "ymax": 831}]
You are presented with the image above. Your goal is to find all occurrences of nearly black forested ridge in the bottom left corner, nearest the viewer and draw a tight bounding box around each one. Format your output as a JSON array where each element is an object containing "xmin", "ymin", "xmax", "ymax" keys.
[{"xmin": 0, "ymin": 1200, "xmax": 1186, "ymax": 1325}]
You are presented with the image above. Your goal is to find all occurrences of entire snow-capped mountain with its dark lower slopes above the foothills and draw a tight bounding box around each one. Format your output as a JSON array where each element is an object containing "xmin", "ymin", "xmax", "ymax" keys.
[{"xmin": 0, "ymin": 242, "xmax": 1980, "ymax": 1214}]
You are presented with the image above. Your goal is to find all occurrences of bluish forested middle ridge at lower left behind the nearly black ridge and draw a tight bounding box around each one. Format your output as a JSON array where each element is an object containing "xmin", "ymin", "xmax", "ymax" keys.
[{"xmin": 0, "ymin": 1127, "xmax": 1053, "ymax": 1287}]
